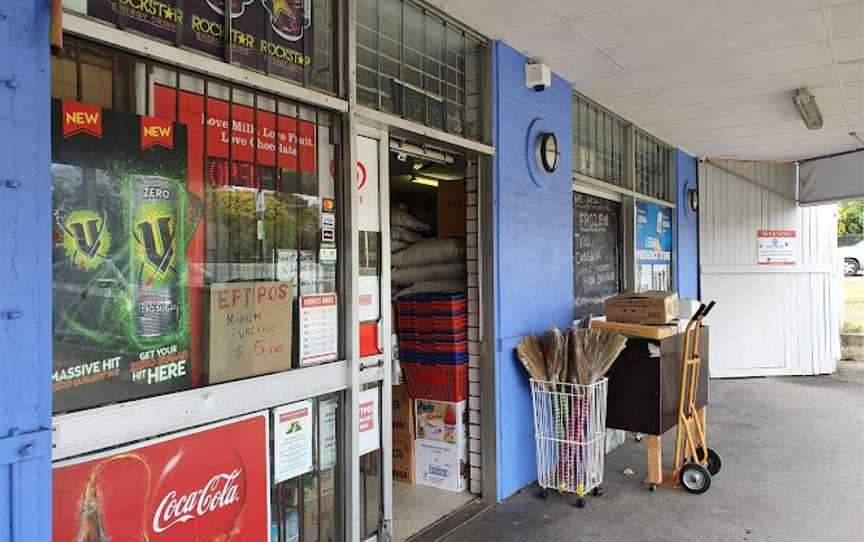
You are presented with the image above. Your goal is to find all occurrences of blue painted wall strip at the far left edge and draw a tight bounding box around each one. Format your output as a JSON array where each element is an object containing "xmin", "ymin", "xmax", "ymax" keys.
[{"xmin": 0, "ymin": 0, "xmax": 51, "ymax": 542}]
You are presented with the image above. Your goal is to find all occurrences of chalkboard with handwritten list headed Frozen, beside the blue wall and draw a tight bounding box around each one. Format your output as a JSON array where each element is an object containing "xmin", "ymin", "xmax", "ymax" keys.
[{"xmin": 573, "ymin": 192, "xmax": 621, "ymax": 319}]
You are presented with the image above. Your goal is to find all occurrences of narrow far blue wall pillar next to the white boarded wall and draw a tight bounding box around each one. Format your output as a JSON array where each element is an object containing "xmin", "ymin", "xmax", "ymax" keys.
[{"xmin": 675, "ymin": 149, "xmax": 699, "ymax": 299}]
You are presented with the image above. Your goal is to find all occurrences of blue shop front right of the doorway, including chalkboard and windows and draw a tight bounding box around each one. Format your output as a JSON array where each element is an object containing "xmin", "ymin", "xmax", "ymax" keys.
[{"xmin": 493, "ymin": 43, "xmax": 698, "ymax": 499}]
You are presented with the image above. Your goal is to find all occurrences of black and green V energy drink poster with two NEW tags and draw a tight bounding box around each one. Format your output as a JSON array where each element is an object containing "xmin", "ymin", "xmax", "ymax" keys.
[{"xmin": 52, "ymin": 100, "xmax": 200, "ymax": 412}]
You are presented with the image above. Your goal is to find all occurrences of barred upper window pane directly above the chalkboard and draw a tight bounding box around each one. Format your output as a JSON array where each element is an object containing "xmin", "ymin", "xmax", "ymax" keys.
[{"xmin": 573, "ymin": 95, "xmax": 627, "ymax": 186}]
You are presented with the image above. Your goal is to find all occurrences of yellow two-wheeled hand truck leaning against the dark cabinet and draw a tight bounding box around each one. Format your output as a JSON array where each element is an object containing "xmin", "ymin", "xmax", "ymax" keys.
[{"xmin": 663, "ymin": 301, "xmax": 721, "ymax": 495}]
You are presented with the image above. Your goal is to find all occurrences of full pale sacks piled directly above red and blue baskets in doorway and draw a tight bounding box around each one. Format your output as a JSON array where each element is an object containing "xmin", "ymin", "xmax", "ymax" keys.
[{"xmin": 390, "ymin": 237, "xmax": 468, "ymax": 297}]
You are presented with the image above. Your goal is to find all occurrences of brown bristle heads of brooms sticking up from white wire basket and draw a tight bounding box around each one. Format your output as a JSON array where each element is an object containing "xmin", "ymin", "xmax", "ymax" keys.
[{"xmin": 516, "ymin": 326, "xmax": 627, "ymax": 388}]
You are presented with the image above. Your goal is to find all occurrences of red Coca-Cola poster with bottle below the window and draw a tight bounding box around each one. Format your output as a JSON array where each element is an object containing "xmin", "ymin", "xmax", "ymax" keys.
[{"xmin": 52, "ymin": 413, "xmax": 270, "ymax": 542}]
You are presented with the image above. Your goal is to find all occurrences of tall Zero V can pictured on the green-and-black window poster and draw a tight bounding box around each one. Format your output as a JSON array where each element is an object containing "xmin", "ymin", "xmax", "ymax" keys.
[{"xmin": 129, "ymin": 175, "xmax": 180, "ymax": 338}]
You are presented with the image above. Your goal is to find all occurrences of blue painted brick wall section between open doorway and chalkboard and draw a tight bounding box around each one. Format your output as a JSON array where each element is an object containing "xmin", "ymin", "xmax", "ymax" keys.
[{"xmin": 493, "ymin": 42, "xmax": 573, "ymax": 499}]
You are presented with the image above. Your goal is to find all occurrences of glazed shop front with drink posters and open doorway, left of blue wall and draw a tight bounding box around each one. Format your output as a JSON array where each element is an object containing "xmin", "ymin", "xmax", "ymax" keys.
[{"xmin": 44, "ymin": 0, "xmax": 494, "ymax": 542}]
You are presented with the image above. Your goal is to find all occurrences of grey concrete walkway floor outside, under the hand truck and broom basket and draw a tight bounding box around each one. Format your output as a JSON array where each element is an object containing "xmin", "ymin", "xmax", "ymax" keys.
[{"xmin": 443, "ymin": 363, "xmax": 864, "ymax": 542}]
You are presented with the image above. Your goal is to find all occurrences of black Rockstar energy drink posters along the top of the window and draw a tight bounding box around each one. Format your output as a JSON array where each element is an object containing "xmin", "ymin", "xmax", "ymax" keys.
[{"xmin": 87, "ymin": 0, "xmax": 314, "ymax": 82}]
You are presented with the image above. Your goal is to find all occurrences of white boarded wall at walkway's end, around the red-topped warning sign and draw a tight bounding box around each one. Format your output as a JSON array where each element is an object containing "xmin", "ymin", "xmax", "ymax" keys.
[{"xmin": 699, "ymin": 160, "xmax": 842, "ymax": 378}]
